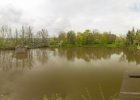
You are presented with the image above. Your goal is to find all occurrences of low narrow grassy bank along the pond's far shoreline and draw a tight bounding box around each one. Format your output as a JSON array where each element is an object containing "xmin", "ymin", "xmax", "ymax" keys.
[{"xmin": 0, "ymin": 43, "xmax": 122, "ymax": 50}]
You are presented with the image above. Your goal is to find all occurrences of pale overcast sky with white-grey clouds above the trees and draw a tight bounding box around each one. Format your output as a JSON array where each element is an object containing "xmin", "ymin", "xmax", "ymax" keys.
[{"xmin": 0, "ymin": 0, "xmax": 140, "ymax": 35}]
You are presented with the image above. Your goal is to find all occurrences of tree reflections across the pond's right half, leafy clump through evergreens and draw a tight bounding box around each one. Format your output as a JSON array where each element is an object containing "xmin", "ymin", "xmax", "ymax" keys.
[{"xmin": 54, "ymin": 48, "xmax": 140, "ymax": 64}]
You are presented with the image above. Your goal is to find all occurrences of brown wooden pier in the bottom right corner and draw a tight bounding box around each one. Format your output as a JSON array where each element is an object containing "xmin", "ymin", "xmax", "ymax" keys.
[{"xmin": 119, "ymin": 72, "xmax": 140, "ymax": 100}]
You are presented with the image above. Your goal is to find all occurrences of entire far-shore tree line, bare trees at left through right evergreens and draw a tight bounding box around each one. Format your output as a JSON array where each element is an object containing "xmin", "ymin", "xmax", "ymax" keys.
[{"xmin": 0, "ymin": 25, "xmax": 140, "ymax": 49}]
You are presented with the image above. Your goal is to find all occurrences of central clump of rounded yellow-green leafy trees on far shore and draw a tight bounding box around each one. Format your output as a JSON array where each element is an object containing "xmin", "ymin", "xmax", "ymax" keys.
[{"xmin": 58, "ymin": 30, "xmax": 117, "ymax": 46}]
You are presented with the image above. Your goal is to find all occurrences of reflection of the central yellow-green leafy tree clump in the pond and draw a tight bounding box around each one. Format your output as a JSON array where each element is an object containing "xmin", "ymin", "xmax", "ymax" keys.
[{"xmin": 58, "ymin": 48, "xmax": 121, "ymax": 62}]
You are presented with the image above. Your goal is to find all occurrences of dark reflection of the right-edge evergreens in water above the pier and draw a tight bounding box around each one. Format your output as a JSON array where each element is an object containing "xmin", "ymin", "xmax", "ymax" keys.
[{"xmin": 120, "ymin": 49, "xmax": 140, "ymax": 64}]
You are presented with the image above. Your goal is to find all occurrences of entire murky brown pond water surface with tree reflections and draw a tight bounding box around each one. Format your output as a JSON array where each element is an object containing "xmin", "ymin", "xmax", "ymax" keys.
[{"xmin": 0, "ymin": 48, "xmax": 140, "ymax": 100}]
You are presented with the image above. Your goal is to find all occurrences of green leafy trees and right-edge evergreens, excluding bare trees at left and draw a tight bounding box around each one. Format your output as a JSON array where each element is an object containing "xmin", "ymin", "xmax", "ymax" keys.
[{"xmin": 50, "ymin": 28, "xmax": 140, "ymax": 48}]
